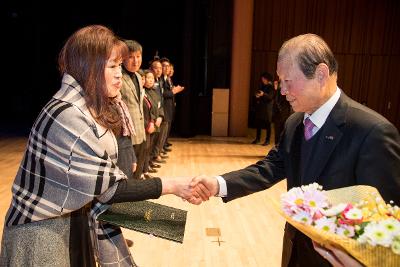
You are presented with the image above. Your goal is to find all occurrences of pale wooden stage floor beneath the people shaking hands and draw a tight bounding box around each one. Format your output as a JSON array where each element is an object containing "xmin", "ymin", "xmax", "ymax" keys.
[{"xmin": 0, "ymin": 136, "xmax": 286, "ymax": 267}]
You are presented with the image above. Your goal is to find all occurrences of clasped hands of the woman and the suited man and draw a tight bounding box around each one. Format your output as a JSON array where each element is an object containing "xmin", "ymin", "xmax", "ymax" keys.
[{"xmin": 161, "ymin": 175, "xmax": 219, "ymax": 205}]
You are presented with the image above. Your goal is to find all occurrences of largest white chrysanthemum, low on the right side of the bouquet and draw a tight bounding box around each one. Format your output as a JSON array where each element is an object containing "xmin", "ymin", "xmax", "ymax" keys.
[{"xmin": 359, "ymin": 222, "xmax": 392, "ymax": 247}]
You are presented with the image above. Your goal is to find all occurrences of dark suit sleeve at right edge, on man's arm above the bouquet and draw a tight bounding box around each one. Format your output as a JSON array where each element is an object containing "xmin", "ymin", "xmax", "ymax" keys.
[{"xmin": 356, "ymin": 122, "xmax": 400, "ymax": 205}]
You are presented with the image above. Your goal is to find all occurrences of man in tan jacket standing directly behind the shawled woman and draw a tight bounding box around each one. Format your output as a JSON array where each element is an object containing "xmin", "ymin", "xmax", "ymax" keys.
[{"xmin": 121, "ymin": 40, "xmax": 146, "ymax": 179}]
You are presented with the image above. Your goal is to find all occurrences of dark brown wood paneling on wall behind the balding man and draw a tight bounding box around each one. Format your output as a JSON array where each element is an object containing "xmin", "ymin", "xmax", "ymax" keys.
[{"xmin": 250, "ymin": 0, "xmax": 400, "ymax": 128}]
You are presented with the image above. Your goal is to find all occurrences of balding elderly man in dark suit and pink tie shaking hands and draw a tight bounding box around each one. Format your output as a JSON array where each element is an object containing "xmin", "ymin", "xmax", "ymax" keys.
[{"xmin": 192, "ymin": 34, "xmax": 400, "ymax": 266}]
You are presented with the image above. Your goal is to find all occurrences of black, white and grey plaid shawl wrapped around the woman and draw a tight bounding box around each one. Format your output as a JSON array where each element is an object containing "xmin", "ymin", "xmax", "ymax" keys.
[{"xmin": 0, "ymin": 74, "xmax": 135, "ymax": 266}]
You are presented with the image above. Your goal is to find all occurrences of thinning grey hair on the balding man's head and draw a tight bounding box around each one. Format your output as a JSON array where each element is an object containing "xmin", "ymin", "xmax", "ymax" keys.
[{"xmin": 278, "ymin": 33, "xmax": 338, "ymax": 79}]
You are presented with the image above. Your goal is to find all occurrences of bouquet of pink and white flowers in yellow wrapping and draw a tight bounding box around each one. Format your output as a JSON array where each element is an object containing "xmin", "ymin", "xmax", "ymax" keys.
[{"xmin": 275, "ymin": 183, "xmax": 400, "ymax": 266}]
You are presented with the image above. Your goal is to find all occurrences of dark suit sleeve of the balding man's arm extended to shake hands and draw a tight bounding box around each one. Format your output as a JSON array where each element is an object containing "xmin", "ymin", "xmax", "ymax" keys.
[{"xmin": 222, "ymin": 147, "xmax": 286, "ymax": 202}]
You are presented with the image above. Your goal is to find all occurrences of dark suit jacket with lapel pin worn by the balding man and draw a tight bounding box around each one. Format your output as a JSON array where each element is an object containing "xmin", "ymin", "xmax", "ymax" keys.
[{"xmin": 223, "ymin": 92, "xmax": 400, "ymax": 266}]
